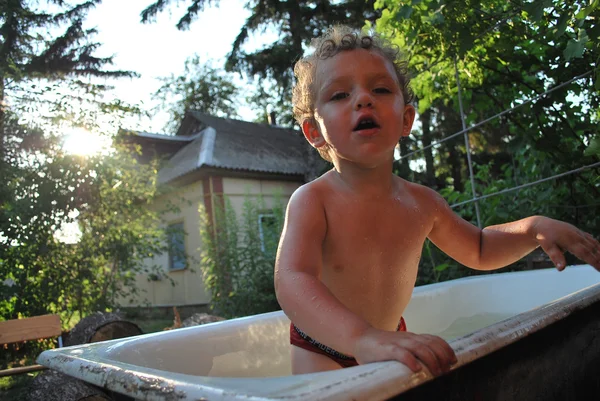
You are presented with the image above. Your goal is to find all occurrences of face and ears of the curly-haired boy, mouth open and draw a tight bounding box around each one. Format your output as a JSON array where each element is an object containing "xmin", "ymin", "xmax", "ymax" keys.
[{"xmin": 302, "ymin": 49, "xmax": 415, "ymax": 167}]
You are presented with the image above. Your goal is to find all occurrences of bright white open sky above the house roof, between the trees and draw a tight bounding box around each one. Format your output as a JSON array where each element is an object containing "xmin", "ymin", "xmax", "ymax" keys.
[{"xmin": 81, "ymin": 0, "xmax": 275, "ymax": 133}]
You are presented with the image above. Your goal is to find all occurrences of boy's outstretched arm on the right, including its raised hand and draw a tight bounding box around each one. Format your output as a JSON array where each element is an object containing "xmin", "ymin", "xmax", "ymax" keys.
[{"xmin": 429, "ymin": 191, "xmax": 600, "ymax": 270}]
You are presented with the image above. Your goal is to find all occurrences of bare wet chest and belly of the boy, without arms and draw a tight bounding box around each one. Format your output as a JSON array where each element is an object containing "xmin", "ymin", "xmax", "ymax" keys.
[{"xmin": 318, "ymin": 172, "xmax": 426, "ymax": 331}]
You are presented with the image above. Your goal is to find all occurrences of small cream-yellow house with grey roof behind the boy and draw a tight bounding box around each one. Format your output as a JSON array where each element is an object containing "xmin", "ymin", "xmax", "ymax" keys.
[{"xmin": 123, "ymin": 111, "xmax": 318, "ymax": 307}]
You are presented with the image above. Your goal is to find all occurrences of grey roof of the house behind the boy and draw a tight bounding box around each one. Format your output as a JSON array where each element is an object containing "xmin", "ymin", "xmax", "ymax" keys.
[{"xmin": 126, "ymin": 111, "xmax": 307, "ymax": 184}]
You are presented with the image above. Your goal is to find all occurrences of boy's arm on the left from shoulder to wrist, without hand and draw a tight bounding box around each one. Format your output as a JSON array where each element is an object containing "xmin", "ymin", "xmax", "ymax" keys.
[{"xmin": 275, "ymin": 186, "xmax": 369, "ymax": 354}]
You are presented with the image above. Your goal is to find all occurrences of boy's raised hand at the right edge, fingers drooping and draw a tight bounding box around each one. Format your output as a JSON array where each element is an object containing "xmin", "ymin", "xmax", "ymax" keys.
[{"xmin": 532, "ymin": 217, "xmax": 600, "ymax": 271}]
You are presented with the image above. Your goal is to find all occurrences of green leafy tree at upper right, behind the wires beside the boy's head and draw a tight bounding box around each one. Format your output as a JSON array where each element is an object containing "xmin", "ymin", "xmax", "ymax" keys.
[{"xmin": 377, "ymin": 0, "xmax": 600, "ymax": 187}]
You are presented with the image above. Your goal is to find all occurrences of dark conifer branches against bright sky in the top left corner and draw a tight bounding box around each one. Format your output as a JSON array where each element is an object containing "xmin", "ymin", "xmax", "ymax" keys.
[{"xmin": 0, "ymin": 0, "xmax": 135, "ymax": 131}]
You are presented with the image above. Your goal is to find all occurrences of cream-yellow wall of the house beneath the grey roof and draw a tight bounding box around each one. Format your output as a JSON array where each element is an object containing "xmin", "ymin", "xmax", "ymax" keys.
[{"xmin": 120, "ymin": 177, "xmax": 301, "ymax": 306}]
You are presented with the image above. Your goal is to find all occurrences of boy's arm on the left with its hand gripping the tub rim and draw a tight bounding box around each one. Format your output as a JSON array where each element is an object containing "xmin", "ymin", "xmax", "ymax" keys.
[{"xmin": 275, "ymin": 186, "xmax": 456, "ymax": 375}]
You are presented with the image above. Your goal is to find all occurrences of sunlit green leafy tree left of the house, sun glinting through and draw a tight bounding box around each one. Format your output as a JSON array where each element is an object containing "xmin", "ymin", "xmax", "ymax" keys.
[{"xmin": 0, "ymin": 119, "xmax": 165, "ymax": 322}]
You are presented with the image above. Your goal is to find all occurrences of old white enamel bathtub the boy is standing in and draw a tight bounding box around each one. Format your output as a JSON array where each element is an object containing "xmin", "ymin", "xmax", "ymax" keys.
[{"xmin": 38, "ymin": 265, "xmax": 600, "ymax": 401}]
